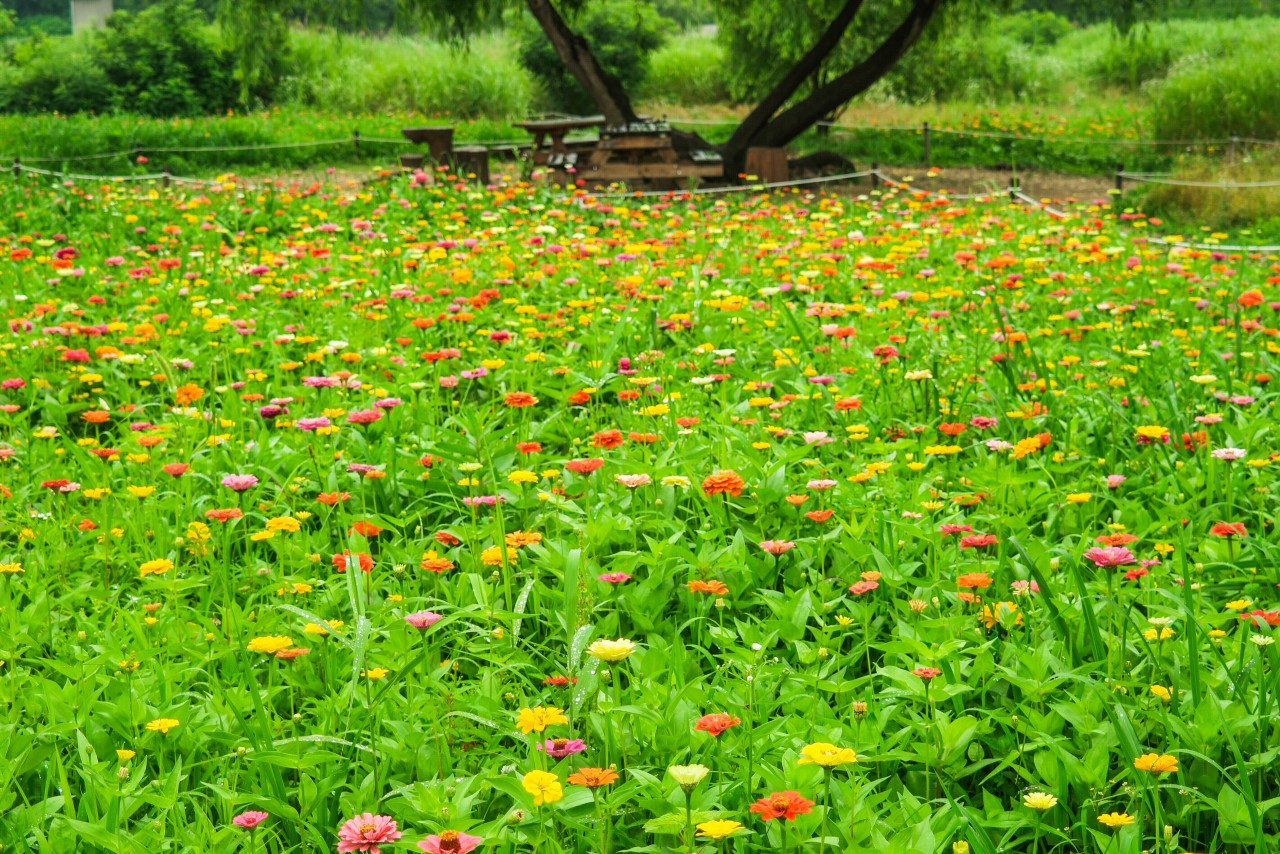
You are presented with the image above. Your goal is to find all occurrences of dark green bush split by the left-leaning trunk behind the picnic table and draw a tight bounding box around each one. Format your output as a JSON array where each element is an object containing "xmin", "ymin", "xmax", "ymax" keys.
[{"xmin": 516, "ymin": 0, "xmax": 671, "ymax": 113}]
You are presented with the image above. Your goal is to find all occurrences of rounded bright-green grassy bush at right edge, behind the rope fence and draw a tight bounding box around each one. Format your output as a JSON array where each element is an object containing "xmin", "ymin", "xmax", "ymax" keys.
[{"xmin": 1151, "ymin": 50, "xmax": 1280, "ymax": 140}]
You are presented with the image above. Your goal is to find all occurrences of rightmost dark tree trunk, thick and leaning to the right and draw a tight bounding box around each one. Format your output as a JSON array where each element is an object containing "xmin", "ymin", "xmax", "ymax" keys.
[{"xmin": 750, "ymin": 0, "xmax": 946, "ymax": 147}]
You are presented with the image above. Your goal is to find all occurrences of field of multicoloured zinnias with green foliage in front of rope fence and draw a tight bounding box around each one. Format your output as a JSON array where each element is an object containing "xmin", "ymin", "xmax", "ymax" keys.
[{"xmin": 0, "ymin": 175, "xmax": 1280, "ymax": 854}]
